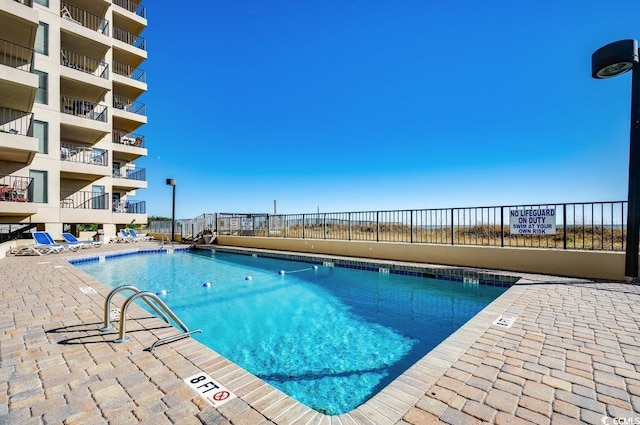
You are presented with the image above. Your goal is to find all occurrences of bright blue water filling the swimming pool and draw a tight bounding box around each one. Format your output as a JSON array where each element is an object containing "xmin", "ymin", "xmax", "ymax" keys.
[{"xmin": 77, "ymin": 248, "xmax": 506, "ymax": 414}]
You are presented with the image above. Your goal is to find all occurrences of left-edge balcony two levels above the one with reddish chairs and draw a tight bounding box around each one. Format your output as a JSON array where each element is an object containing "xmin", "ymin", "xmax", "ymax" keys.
[{"xmin": 0, "ymin": 39, "xmax": 38, "ymax": 110}]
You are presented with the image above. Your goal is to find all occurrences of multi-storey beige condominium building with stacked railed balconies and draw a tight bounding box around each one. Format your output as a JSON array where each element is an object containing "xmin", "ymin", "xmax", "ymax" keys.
[{"xmin": 0, "ymin": 0, "xmax": 147, "ymax": 242}]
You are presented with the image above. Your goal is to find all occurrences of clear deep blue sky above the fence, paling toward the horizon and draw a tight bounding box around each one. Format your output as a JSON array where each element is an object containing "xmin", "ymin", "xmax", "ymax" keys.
[{"xmin": 137, "ymin": 0, "xmax": 640, "ymax": 218}]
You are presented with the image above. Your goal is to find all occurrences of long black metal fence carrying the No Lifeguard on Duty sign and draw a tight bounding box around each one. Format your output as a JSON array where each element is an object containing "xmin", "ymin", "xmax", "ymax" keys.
[{"xmin": 204, "ymin": 201, "xmax": 627, "ymax": 251}]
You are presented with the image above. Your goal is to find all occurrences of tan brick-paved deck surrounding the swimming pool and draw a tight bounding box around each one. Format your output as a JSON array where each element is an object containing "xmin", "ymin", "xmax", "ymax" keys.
[{"xmin": 0, "ymin": 243, "xmax": 640, "ymax": 425}]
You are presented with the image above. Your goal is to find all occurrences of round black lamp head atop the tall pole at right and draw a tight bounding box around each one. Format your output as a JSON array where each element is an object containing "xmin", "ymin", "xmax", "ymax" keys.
[{"xmin": 591, "ymin": 39, "xmax": 639, "ymax": 78}]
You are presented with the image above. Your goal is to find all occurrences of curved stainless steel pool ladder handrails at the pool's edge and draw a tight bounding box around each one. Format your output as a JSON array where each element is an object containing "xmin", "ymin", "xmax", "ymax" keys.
[{"xmin": 100, "ymin": 285, "xmax": 202, "ymax": 352}]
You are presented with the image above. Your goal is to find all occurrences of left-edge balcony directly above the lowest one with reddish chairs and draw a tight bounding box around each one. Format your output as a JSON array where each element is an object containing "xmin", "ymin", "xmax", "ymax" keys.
[{"xmin": 0, "ymin": 108, "xmax": 38, "ymax": 164}]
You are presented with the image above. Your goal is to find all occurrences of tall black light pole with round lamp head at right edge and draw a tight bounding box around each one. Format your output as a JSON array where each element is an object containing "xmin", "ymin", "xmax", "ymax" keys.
[{"xmin": 591, "ymin": 40, "xmax": 640, "ymax": 283}]
